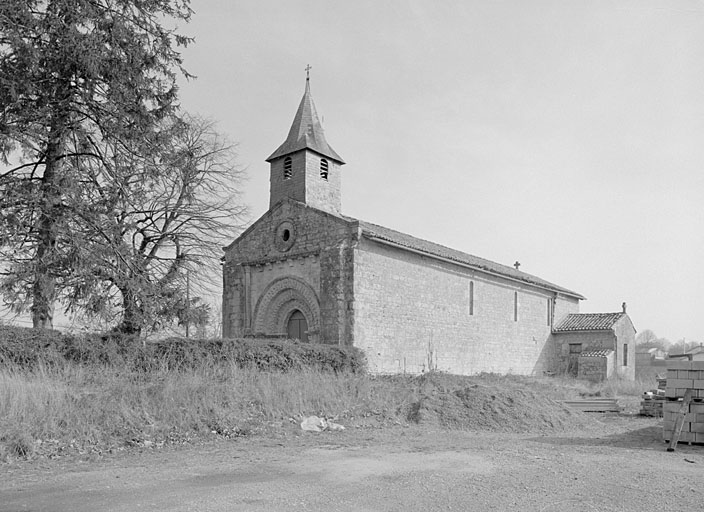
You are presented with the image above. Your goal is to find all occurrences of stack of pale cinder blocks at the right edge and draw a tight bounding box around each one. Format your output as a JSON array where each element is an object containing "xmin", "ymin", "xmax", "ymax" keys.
[{"xmin": 663, "ymin": 361, "xmax": 704, "ymax": 444}]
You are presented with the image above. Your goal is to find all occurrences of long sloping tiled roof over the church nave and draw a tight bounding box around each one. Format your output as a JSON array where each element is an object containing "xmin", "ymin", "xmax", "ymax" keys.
[{"xmin": 345, "ymin": 217, "xmax": 585, "ymax": 299}]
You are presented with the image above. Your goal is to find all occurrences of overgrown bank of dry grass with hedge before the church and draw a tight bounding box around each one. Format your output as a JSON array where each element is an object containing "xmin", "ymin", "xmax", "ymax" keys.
[{"xmin": 0, "ymin": 327, "xmax": 654, "ymax": 461}]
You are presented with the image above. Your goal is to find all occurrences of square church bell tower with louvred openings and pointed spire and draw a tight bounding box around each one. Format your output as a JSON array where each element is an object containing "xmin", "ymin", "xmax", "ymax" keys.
[{"xmin": 266, "ymin": 66, "xmax": 345, "ymax": 215}]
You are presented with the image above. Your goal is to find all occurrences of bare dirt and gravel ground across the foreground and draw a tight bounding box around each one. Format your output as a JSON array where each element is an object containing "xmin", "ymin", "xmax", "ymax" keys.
[{"xmin": 0, "ymin": 413, "xmax": 704, "ymax": 512}]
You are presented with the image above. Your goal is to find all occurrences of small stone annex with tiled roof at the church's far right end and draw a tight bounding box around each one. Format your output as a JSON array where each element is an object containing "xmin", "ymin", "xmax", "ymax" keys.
[{"xmin": 553, "ymin": 304, "xmax": 636, "ymax": 380}]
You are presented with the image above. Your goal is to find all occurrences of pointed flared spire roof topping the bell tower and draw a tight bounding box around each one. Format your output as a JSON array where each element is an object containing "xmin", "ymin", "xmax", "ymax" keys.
[{"xmin": 266, "ymin": 79, "xmax": 345, "ymax": 164}]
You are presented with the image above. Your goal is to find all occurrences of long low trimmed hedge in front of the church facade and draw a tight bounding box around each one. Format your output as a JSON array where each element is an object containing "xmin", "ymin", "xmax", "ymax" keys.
[{"xmin": 0, "ymin": 325, "xmax": 366, "ymax": 372}]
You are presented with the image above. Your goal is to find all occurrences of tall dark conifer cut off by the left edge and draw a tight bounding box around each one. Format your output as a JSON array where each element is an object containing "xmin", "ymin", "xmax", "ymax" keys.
[{"xmin": 0, "ymin": 0, "xmax": 191, "ymax": 328}]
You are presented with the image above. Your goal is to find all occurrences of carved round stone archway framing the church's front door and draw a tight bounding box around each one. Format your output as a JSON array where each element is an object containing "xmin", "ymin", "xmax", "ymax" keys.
[{"xmin": 253, "ymin": 277, "xmax": 320, "ymax": 342}]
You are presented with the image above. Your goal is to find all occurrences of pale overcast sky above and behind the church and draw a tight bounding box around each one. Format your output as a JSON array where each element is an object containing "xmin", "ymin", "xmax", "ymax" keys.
[{"xmin": 170, "ymin": 0, "xmax": 704, "ymax": 341}]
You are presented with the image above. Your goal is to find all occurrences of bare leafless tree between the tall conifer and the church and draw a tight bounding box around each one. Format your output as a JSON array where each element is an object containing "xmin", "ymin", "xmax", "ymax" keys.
[{"xmin": 63, "ymin": 116, "xmax": 245, "ymax": 333}]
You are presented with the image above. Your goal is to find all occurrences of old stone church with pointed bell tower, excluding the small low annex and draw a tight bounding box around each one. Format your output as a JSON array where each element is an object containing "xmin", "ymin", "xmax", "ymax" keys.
[{"xmin": 222, "ymin": 79, "xmax": 635, "ymax": 375}]
